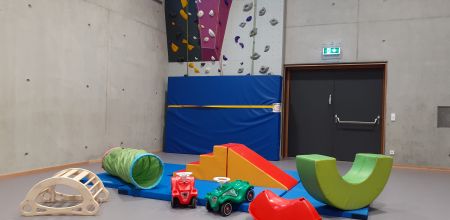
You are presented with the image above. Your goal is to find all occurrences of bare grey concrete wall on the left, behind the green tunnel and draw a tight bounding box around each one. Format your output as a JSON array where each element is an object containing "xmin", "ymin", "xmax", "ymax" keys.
[{"xmin": 0, "ymin": 0, "xmax": 167, "ymax": 174}]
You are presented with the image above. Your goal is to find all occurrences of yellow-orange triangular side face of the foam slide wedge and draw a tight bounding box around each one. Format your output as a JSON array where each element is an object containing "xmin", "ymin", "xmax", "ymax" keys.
[{"xmin": 228, "ymin": 150, "xmax": 288, "ymax": 190}]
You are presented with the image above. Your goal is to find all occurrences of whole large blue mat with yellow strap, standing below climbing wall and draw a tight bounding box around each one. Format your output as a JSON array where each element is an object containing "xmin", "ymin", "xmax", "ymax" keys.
[{"xmin": 164, "ymin": 76, "xmax": 282, "ymax": 160}]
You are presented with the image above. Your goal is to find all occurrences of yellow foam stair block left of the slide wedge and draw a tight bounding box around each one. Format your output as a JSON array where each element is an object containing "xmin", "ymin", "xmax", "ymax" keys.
[{"xmin": 186, "ymin": 146, "xmax": 228, "ymax": 180}]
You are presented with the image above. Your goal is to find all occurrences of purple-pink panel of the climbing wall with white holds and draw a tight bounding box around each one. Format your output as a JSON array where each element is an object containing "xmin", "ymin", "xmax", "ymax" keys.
[{"xmin": 197, "ymin": 0, "xmax": 232, "ymax": 61}]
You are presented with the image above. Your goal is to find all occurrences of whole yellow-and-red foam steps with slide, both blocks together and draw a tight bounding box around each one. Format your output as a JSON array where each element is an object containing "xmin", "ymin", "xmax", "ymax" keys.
[{"xmin": 186, "ymin": 143, "xmax": 298, "ymax": 190}]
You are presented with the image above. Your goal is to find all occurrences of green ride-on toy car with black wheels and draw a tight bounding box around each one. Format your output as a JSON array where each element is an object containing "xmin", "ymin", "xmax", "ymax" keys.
[{"xmin": 206, "ymin": 177, "xmax": 255, "ymax": 216}]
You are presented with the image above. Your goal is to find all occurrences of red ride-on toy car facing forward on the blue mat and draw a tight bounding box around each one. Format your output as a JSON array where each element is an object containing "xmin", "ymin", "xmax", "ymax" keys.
[{"xmin": 171, "ymin": 172, "xmax": 198, "ymax": 208}]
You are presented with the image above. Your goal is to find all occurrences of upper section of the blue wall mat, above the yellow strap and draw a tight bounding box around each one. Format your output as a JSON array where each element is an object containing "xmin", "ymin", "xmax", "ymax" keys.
[{"xmin": 167, "ymin": 76, "xmax": 282, "ymax": 105}]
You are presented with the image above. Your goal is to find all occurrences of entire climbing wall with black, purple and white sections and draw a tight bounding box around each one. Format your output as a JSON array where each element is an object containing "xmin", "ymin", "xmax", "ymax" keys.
[{"xmin": 166, "ymin": 0, "xmax": 285, "ymax": 76}]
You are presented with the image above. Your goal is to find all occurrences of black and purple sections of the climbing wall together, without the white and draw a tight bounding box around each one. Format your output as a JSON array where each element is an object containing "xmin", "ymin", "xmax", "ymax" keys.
[{"xmin": 165, "ymin": 0, "xmax": 232, "ymax": 63}]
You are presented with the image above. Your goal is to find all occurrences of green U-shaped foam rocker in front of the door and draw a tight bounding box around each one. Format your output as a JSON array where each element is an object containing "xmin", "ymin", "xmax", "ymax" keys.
[{"xmin": 296, "ymin": 153, "xmax": 393, "ymax": 210}]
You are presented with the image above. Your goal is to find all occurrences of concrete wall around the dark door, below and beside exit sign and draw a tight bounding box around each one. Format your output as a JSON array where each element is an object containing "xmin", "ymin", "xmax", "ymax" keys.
[{"xmin": 285, "ymin": 0, "xmax": 450, "ymax": 167}]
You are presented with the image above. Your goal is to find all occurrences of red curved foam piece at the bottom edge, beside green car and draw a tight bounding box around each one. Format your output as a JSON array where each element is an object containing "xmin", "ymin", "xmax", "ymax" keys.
[{"xmin": 248, "ymin": 190, "xmax": 322, "ymax": 220}]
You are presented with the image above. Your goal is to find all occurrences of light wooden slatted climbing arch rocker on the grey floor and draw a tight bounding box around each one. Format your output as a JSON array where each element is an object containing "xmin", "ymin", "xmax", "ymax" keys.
[{"xmin": 20, "ymin": 168, "xmax": 109, "ymax": 216}]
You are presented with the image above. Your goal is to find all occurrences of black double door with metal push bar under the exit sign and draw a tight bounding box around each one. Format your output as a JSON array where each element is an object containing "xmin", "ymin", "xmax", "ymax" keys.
[{"xmin": 288, "ymin": 68, "xmax": 384, "ymax": 161}]
